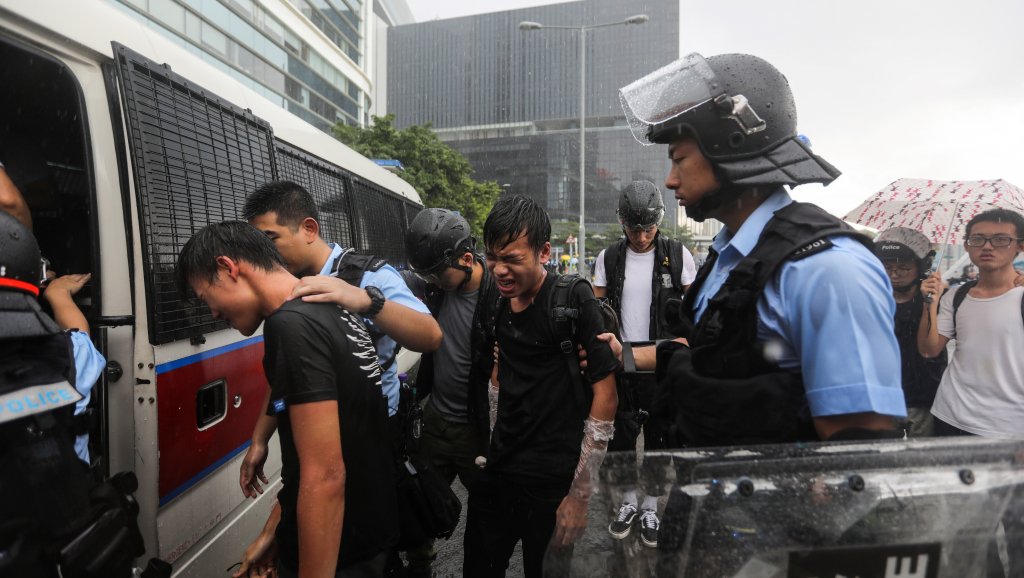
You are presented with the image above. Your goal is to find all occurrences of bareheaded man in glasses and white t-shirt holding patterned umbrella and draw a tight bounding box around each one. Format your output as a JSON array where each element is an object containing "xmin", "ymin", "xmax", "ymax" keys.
[{"xmin": 918, "ymin": 209, "xmax": 1024, "ymax": 440}]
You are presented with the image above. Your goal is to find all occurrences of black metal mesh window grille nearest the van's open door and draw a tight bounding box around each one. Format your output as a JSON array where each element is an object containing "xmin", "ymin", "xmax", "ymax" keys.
[{"xmin": 115, "ymin": 44, "xmax": 275, "ymax": 344}]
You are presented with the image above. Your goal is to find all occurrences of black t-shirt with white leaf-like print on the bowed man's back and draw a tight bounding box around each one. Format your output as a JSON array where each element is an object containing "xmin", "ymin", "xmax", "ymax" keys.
[{"xmin": 263, "ymin": 299, "xmax": 398, "ymax": 569}]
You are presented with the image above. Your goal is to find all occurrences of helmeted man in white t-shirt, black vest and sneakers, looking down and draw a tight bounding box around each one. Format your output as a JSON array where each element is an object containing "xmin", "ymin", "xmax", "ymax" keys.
[{"xmin": 594, "ymin": 180, "xmax": 696, "ymax": 548}]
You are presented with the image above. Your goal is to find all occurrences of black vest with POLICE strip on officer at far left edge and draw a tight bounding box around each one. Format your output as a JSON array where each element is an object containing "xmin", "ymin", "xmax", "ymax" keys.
[{"xmin": 0, "ymin": 333, "xmax": 149, "ymax": 578}]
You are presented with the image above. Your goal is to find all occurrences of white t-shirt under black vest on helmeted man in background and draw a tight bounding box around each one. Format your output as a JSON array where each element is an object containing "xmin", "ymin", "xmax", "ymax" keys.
[{"xmin": 594, "ymin": 240, "xmax": 697, "ymax": 341}]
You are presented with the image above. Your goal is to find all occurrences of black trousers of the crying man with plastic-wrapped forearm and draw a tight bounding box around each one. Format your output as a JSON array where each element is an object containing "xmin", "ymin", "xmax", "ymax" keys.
[{"xmin": 463, "ymin": 473, "xmax": 572, "ymax": 578}]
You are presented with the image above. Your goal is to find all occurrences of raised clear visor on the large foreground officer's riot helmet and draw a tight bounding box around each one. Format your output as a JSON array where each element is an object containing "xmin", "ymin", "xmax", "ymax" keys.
[{"xmin": 618, "ymin": 52, "xmax": 722, "ymax": 145}]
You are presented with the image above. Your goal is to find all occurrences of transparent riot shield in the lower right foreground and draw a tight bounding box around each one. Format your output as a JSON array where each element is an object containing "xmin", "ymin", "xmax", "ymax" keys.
[{"xmin": 561, "ymin": 438, "xmax": 1024, "ymax": 578}]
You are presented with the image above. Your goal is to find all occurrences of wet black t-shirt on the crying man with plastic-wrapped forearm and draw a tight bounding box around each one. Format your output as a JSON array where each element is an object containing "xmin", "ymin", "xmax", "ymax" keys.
[{"xmin": 486, "ymin": 274, "xmax": 618, "ymax": 487}]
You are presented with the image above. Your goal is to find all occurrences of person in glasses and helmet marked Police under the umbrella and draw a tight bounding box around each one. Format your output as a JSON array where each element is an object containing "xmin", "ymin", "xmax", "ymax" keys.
[{"xmin": 874, "ymin": 226, "xmax": 946, "ymax": 438}]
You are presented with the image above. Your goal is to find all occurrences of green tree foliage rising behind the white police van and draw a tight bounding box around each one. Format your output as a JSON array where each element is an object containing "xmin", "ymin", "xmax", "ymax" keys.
[{"xmin": 334, "ymin": 115, "xmax": 501, "ymax": 239}]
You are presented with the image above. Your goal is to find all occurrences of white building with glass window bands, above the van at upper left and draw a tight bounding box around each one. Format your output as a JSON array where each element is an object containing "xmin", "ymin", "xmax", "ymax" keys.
[{"xmin": 113, "ymin": 0, "xmax": 373, "ymax": 131}]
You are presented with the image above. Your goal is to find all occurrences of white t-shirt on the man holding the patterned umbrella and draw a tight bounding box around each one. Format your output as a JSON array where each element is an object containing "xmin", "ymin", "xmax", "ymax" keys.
[{"xmin": 932, "ymin": 287, "xmax": 1024, "ymax": 440}]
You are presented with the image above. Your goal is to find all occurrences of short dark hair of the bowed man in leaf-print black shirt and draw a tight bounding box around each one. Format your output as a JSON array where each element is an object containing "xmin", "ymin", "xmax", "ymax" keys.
[{"xmin": 175, "ymin": 220, "xmax": 285, "ymax": 296}]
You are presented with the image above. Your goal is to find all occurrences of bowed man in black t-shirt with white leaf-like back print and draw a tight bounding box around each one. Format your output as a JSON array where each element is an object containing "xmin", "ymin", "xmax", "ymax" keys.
[{"xmin": 177, "ymin": 221, "xmax": 398, "ymax": 577}]
